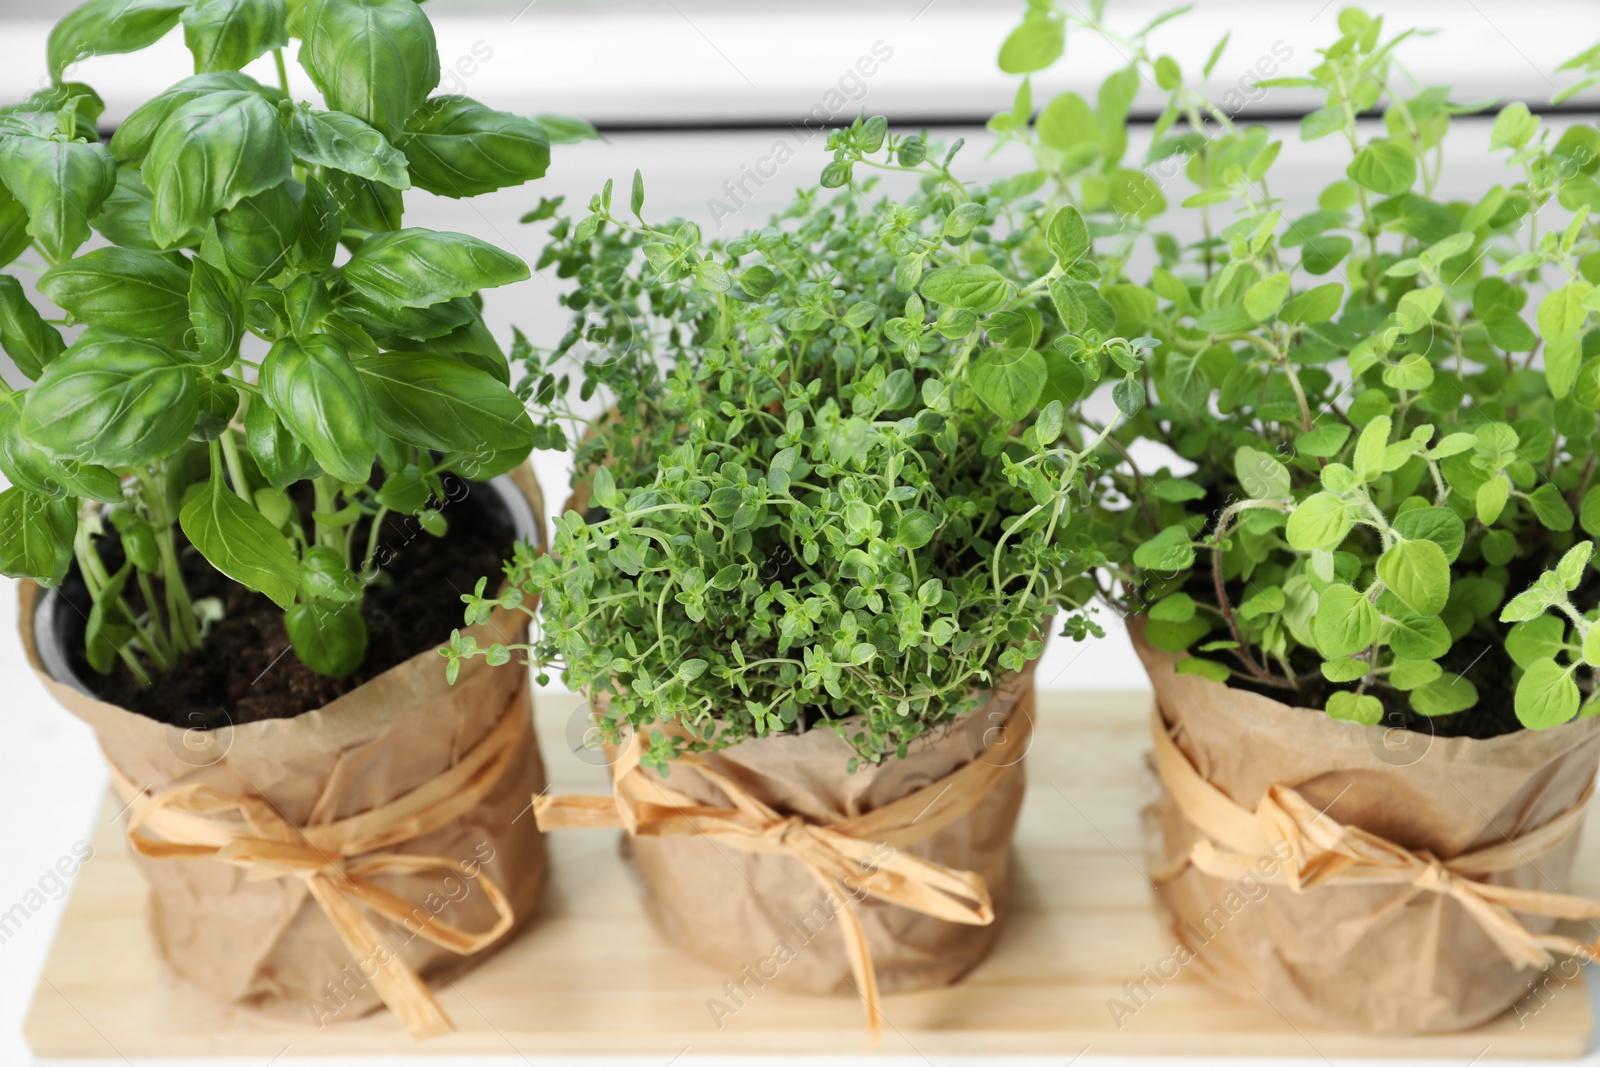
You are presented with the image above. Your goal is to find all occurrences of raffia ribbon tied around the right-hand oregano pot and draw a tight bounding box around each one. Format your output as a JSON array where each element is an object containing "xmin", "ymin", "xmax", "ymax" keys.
[{"xmin": 1150, "ymin": 710, "xmax": 1600, "ymax": 968}]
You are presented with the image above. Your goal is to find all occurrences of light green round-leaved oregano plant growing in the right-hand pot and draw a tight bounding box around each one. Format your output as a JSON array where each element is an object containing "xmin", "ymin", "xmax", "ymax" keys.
[{"xmin": 990, "ymin": 0, "xmax": 1600, "ymax": 736}]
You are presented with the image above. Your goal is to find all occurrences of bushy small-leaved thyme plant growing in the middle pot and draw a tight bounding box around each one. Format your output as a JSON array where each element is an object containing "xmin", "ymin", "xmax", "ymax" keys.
[{"xmin": 442, "ymin": 118, "xmax": 1146, "ymax": 773}]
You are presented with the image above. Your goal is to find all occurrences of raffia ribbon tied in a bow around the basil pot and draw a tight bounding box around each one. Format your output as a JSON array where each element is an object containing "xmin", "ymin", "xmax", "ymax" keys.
[{"xmin": 107, "ymin": 683, "xmax": 530, "ymax": 1038}]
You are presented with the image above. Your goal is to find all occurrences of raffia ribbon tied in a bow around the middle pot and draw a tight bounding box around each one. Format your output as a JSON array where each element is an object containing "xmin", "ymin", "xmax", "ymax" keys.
[{"xmin": 533, "ymin": 694, "xmax": 1034, "ymax": 1041}]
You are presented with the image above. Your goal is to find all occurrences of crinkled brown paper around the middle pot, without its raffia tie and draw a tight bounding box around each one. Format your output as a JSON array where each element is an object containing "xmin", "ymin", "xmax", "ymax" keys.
[{"xmin": 632, "ymin": 661, "xmax": 1037, "ymax": 993}]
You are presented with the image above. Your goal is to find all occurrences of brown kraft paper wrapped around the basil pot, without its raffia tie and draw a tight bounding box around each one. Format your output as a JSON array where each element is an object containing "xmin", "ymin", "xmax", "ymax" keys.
[{"xmin": 12, "ymin": 470, "xmax": 546, "ymax": 1022}]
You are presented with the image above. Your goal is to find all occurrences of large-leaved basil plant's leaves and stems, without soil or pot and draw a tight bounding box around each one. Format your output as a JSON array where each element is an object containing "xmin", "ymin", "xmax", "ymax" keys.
[{"xmin": 0, "ymin": 0, "xmax": 586, "ymax": 681}]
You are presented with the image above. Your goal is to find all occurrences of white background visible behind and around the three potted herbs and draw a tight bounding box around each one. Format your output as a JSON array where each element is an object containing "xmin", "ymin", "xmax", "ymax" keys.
[{"xmin": 0, "ymin": 0, "xmax": 1600, "ymax": 1065}]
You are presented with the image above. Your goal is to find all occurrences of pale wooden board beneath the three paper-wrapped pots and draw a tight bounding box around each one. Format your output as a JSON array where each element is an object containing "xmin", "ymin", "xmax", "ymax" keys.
[{"xmin": 24, "ymin": 693, "xmax": 1600, "ymax": 1062}]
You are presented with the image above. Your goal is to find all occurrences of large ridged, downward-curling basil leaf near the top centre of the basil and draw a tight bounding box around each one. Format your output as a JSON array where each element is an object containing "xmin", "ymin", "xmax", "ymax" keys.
[{"xmin": 142, "ymin": 90, "xmax": 293, "ymax": 248}]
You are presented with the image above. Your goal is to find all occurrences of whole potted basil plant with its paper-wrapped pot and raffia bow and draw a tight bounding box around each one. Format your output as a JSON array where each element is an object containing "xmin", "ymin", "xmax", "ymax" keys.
[{"xmin": 0, "ymin": 0, "xmax": 582, "ymax": 1035}]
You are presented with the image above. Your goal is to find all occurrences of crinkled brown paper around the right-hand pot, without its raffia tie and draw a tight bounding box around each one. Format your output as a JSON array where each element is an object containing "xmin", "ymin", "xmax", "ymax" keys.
[{"xmin": 1130, "ymin": 619, "xmax": 1600, "ymax": 1035}]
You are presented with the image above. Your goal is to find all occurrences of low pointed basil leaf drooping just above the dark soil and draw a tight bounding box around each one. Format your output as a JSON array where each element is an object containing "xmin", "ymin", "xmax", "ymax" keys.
[{"xmin": 178, "ymin": 473, "xmax": 299, "ymax": 608}]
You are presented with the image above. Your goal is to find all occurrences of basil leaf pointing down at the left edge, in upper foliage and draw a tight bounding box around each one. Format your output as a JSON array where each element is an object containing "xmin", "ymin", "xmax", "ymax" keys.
[{"xmin": 0, "ymin": 133, "xmax": 117, "ymax": 262}]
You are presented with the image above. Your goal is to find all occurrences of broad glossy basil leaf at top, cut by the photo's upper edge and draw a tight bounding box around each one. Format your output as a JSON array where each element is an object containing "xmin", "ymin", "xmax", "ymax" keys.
[{"xmin": 299, "ymin": 0, "xmax": 438, "ymax": 139}]
